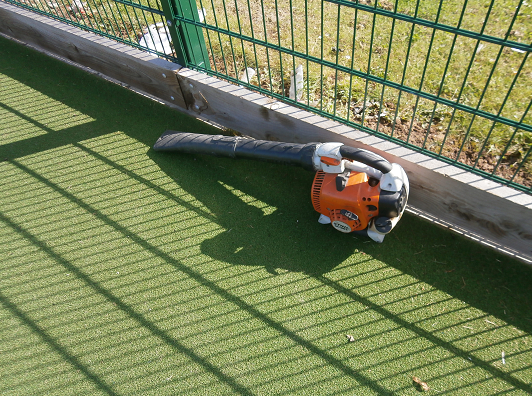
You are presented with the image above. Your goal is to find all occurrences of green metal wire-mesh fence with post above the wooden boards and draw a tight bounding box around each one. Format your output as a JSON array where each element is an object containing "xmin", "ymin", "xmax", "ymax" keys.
[{"xmin": 4, "ymin": 0, "xmax": 532, "ymax": 193}]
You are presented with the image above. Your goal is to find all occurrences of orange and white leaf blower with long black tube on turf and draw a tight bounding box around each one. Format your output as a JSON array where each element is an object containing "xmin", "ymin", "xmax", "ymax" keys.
[{"xmin": 153, "ymin": 131, "xmax": 410, "ymax": 242}]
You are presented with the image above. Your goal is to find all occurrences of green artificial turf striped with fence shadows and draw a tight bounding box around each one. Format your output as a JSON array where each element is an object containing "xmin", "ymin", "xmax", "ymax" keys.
[{"xmin": 0, "ymin": 38, "xmax": 532, "ymax": 396}]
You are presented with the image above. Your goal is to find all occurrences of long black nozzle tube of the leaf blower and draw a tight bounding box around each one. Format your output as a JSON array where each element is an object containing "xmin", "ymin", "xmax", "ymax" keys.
[{"xmin": 153, "ymin": 131, "xmax": 316, "ymax": 170}]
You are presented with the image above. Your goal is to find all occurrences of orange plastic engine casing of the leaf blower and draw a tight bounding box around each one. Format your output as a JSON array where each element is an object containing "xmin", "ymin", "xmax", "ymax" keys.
[{"xmin": 311, "ymin": 171, "xmax": 380, "ymax": 232}]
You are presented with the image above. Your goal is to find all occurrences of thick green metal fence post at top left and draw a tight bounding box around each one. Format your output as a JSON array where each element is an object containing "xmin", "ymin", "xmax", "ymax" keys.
[{"xmin": 161, "ymin": 0, "xmax": 211, "ymax": 70}]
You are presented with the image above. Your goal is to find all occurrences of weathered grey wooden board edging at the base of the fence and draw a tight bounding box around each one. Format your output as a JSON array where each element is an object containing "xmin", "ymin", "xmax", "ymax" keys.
[{"xmin": 0, "ymin": 2, "xmax": 532, "ymax": 264}]
